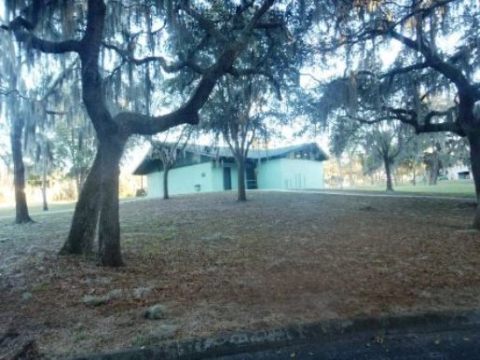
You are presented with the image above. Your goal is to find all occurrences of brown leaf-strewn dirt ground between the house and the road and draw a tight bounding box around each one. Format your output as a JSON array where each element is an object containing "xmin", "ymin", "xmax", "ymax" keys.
[{"xmin": 0, "ymin": 192, "xmax": 480, "ymax": 358}]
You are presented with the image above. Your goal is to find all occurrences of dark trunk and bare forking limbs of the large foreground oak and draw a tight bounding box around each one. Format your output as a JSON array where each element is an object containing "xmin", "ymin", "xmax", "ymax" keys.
[{"xmin": 9, "ymin": 0, "xmax": 274, "ymax": 266}]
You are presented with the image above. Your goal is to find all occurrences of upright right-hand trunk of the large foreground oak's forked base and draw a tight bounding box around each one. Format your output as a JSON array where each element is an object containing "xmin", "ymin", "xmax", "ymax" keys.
[{"xmin": 98, "ymin": 136, "xmax": 126, "ymax": 266}]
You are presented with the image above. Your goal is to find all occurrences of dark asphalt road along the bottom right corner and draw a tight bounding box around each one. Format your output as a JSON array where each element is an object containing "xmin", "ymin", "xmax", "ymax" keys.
[{"xmin": 210, "ymin": 325, "xmax": 480, "ymax": 360}]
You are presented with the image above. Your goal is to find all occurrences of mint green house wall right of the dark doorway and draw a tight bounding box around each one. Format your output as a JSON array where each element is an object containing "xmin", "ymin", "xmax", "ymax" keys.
[{"xmin": 257, "ymin": 158, "xmax": 324, "ymax": 189}]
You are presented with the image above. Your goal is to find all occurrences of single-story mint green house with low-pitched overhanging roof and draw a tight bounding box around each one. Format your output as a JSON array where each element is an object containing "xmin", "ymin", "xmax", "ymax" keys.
[{"xmin": 134, "ymin": 143, "xmax": 327, "ymax": 197}]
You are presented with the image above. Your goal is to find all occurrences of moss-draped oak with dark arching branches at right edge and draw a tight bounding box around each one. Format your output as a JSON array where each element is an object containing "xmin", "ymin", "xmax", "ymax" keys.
[{"xmin": 312, "ymin": 0, "xmax": 480, "ymax": 229}]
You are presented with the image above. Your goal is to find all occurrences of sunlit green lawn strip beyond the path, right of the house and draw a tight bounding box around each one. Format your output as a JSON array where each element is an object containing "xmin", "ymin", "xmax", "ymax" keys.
[{"xmin": 348, "ymin": 180, "xmax": 475, "ymax": 198}]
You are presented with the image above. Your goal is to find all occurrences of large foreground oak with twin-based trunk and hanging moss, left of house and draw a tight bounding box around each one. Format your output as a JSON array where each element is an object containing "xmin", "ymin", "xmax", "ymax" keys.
[{"xmin": 3, "ymin": 0, "xmax": 296, "ymax": 266}]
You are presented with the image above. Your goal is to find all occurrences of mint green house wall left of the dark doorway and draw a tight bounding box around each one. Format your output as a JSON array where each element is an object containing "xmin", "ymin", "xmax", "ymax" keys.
[{"xmin": 147, "ymin": 162, "xmax": 242, "ymax": 197}]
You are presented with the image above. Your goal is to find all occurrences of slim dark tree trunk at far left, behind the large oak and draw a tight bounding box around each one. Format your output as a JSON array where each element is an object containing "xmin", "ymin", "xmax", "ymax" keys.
[{"xmin": 11, "ymin": 118, "xmax": 32, "ymax": 224}]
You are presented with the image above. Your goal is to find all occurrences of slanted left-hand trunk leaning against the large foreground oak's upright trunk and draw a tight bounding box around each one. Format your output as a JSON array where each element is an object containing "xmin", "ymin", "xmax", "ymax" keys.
[{"xmin": 60, "ymin": 151, "xmax": 102, "ymax": 254}]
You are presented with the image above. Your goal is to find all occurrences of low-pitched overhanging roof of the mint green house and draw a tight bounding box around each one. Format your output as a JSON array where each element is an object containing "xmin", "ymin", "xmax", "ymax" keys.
[{"xmin": 133, "ymin": 143, "xmax": 328, "ymax": 175}]
